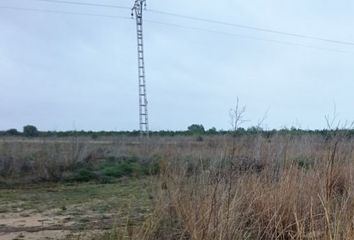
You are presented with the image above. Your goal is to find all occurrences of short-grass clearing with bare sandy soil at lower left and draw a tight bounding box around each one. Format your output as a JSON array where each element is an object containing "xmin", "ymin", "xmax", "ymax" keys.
[{"xmin": 0, "ymin": 180, "xmax": 151, "ymax": 240}]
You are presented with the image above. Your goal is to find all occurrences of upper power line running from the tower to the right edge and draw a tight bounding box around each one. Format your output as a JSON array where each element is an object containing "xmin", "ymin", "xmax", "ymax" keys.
[{"xmin": 148, "ymin": 9, "xmax": 354, "ymax": 46}]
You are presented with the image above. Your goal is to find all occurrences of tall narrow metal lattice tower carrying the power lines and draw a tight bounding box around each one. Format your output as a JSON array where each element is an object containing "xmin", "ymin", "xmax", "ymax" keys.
[{"xmin": 132, "ymin": 0, "xmax": 149, "ymax": 136}]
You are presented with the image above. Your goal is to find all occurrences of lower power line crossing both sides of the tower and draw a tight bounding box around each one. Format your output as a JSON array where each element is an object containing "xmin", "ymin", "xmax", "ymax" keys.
[{"xmin": 0, "ymin": 6, "xmax": 354, "ymax": 54}]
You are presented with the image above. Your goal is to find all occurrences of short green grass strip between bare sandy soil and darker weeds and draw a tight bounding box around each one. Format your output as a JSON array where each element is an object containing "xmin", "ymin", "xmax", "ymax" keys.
[{"xmin": 0, "ymin": 178, "xmax": 151, "ymax": 216}]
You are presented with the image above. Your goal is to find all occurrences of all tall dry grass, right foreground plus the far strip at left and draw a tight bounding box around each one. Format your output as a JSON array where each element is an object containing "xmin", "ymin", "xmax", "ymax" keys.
[{"xmin": 0, "ymin": 135, "xmax": 354, "ymax": 240}]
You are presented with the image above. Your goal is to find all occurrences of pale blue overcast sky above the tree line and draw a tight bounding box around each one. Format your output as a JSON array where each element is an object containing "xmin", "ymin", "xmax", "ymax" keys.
[{"xmin": 0, "ymin": 0, "xmax": 354, "ymax": 131}]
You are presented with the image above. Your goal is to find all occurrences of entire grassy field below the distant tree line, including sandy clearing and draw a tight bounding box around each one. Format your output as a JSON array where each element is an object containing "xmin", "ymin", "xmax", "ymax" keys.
[{"xmin": 0, "ymin": 132, "xmax": 354, "ymax": 240}]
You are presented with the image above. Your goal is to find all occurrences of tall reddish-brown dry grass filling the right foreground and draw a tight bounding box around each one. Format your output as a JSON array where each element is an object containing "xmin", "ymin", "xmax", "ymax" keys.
[{"xmin": 111, "ymin": 136, "xmax": 354, "ymax": 240}]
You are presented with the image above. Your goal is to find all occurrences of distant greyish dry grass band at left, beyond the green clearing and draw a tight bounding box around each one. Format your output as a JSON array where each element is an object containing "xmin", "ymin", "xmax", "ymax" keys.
[{"xmin": 0, "ymin": 134, "xmax": 225, "ymax": 185}]
